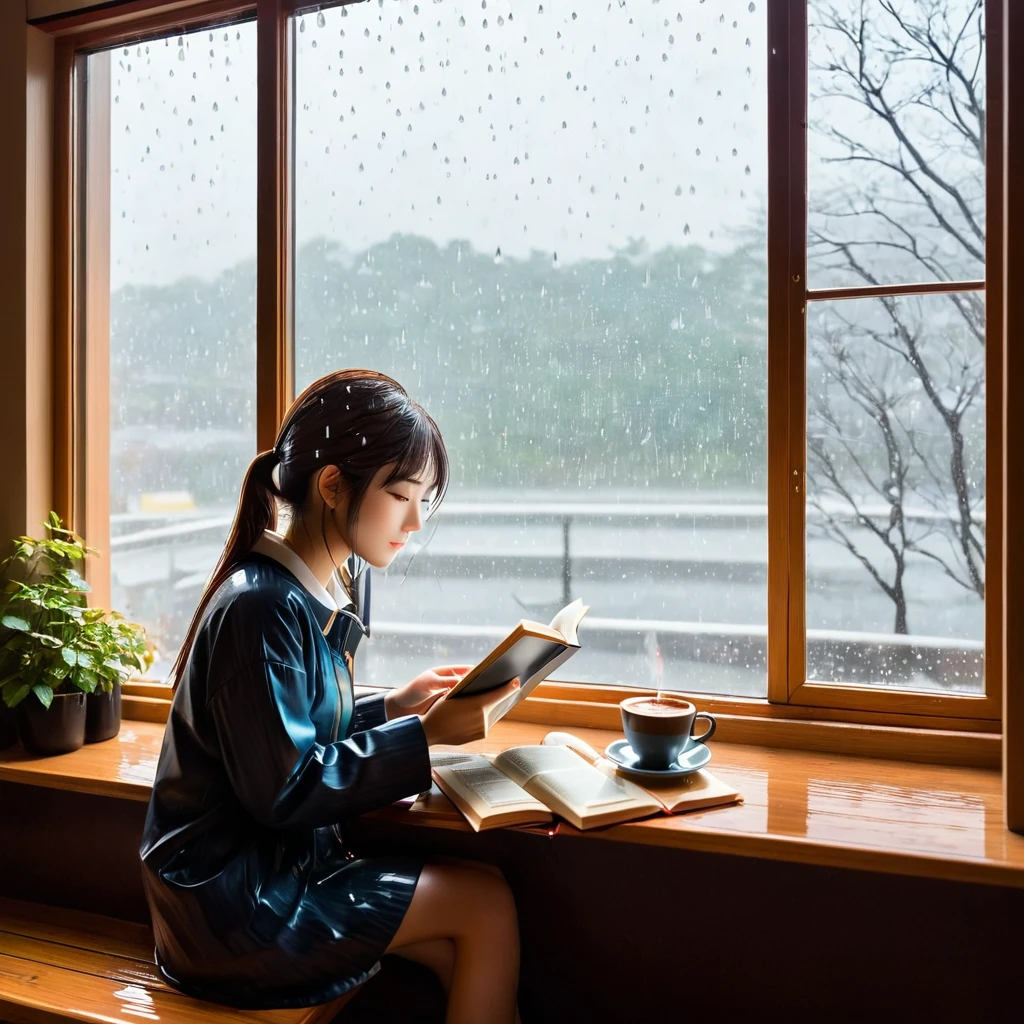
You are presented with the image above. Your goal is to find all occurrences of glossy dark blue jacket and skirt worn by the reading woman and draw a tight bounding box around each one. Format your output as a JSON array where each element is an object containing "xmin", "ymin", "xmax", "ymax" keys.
[{"xmin": 141, "ymin": 553, "xmax": 430, "ymax": 1009}]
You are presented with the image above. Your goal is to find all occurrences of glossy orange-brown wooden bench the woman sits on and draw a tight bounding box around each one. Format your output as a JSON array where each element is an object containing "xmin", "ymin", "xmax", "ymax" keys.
[{"xmin": 0, "ymin": 899, "xmax": 353, "ymax": 1024}]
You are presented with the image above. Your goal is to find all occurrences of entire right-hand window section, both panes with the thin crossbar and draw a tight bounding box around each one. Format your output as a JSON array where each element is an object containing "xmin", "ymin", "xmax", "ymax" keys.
[{"xmin": 806, "ymin": 0, "xmax": 986, "ymax": 694}]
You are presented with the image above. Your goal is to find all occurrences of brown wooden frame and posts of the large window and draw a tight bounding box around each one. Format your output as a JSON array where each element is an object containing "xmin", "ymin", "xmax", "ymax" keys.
[{"xmin": 39, "ymin": 0, "xmax": 1024, "ymax": 770}]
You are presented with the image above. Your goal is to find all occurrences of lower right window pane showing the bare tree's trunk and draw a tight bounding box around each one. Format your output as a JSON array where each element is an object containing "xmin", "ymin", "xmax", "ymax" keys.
[{"xmin": 807, "ymin": 292, "xmax": 985, "ymax": 692}]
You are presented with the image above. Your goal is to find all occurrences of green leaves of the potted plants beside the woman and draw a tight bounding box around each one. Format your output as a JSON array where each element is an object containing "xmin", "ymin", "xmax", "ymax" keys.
[{"xmin": 0, "ymin": 513, "xmax": 146, "ymax": 708}]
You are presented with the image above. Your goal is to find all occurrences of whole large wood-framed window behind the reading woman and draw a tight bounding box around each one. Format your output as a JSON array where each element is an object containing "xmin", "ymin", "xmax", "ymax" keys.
[{"xmin": 48, "ymin": 0, "xmax": 1001, "ymax": 731}]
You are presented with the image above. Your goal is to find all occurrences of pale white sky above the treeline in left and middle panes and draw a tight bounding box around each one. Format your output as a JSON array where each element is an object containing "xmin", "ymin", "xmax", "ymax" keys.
[{"xmin": 111, "ymin": 0, "xmax": 767, "ymax": 288}]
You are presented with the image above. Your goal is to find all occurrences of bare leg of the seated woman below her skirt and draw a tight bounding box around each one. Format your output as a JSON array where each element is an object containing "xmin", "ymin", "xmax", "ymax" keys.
[{"xmin": 388, "ymin": 864, "xmax": 519, "ymax": 1024}]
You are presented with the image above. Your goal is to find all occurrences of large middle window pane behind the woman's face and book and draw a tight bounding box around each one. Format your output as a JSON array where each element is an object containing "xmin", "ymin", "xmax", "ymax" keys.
[{"xmin": 294, "ymin": 0, "xmax": 767, "ymax": 695}]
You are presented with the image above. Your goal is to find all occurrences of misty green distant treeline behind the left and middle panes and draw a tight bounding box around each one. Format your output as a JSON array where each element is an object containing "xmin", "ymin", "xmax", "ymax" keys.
[{"xmin": 111, "ymin": 236, "xmax": 767, "ymax": 510}]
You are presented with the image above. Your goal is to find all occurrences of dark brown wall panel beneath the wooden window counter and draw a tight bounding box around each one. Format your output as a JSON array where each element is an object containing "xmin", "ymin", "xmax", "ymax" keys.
[{"xmin": 0, "ymin": 783, "xmax": 1024, "ymax": 1024}]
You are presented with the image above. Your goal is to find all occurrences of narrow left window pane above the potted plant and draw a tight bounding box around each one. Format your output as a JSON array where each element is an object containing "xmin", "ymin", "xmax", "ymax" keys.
[{"xmin": 95, "ymin": 24, "xmax": 256, "ymax": 677}]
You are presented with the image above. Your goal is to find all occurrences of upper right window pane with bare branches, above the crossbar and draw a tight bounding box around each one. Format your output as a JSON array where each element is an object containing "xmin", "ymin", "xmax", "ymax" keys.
[{"xmin": 808, "ymin": 0, "xmax": 985, "ymax": 288}]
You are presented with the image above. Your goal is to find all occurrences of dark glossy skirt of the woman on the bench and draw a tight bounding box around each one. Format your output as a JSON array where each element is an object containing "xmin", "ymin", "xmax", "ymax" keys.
[{"xmin": 147, "ymin": 853, "xmax": 423, "ymax": 1010}]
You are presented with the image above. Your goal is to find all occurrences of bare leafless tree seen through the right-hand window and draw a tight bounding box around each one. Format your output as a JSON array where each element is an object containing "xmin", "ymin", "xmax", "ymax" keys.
[{"xmin": 808, "ymin": 0, "xmax": 985, "ymax": 633}]
